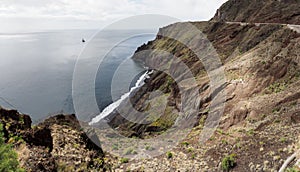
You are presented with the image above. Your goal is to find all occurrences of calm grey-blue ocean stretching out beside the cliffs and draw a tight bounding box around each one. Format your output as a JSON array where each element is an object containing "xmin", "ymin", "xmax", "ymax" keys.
[{"xmin": 0, "ymin": 30, "xmax": 155, "ymax": 123}]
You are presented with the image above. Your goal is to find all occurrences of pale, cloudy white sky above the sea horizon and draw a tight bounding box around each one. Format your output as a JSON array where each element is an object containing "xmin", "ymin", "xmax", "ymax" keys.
[{"xmin": 0, "ymin": 0, "xmax": 226, "ymax": 33}]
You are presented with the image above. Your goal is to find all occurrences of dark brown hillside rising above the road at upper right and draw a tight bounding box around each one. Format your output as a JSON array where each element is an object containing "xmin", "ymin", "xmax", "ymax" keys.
[{"xmin": 212, "ymin": 0, "xmax": 300, "ymax": 24}]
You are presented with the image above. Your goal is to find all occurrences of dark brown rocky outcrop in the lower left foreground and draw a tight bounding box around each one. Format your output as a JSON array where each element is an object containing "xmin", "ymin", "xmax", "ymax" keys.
[{"xmin": 0, "ymin": 108, "xmax": 106, "ymax": 171}]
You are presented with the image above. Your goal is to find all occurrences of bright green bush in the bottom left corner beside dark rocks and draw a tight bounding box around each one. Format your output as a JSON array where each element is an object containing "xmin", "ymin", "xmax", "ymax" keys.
[{"xmin": 0, "ymin": 123, "xmax": 25, "ymax": 172}]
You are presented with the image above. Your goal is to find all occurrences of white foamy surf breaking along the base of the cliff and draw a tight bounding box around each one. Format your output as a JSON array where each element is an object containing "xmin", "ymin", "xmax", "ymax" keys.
[{"xmin": 89, "ymin": 71, "xmax": 153, "ymax": 125}]
